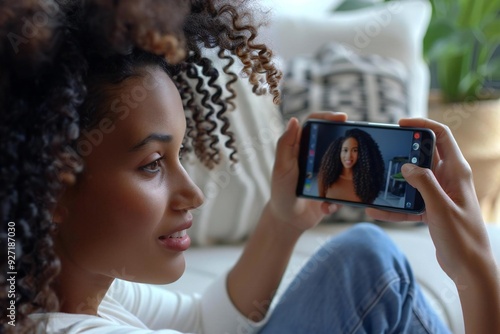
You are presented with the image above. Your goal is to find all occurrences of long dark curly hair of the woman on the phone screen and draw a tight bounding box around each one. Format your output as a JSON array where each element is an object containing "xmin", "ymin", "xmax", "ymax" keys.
[{"xmin": 319, "ymin": 129, "xmax": 385, "ymax": 203}]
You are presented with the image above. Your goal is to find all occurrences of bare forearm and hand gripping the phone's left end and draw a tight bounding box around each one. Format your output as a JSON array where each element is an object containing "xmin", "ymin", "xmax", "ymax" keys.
[{"xmin": 227, "ymin": 113, "xmax": 347, "ymax": 321}]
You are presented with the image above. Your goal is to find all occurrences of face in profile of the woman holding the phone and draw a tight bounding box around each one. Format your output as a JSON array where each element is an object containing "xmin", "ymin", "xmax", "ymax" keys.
[{"xmin": 56, "ymin": 68, "xmax": 203, "ymax": 283}]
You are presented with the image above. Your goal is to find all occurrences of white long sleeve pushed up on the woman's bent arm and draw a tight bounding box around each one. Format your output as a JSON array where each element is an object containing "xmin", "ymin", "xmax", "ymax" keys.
[{"xmin": 107, "ymin": 275, "xmax": 266, "ymax": 334}]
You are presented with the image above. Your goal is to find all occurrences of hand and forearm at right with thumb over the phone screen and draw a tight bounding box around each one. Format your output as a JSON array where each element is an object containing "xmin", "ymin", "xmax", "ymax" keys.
[{"xmin": 367, "ymin": 119, "xmax": 500, "ymax": 333}]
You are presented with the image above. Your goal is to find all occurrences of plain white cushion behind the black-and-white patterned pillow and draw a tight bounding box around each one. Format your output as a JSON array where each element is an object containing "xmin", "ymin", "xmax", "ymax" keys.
[{"xmin": 263, "ymin": 0, "xmax": 431, "ymax": 116}]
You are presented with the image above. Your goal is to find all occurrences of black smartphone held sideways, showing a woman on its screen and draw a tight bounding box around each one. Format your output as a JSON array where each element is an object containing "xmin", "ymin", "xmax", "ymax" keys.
[{"xmin": 296, "ymin": 119, "xmax": 436, "ymax": 214}]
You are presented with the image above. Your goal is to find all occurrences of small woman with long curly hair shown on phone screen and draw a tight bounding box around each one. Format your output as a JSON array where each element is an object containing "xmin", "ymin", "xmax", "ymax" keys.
[{"xmin": 318, "ymin": 129, "xmax": 385, "ymax": 203}]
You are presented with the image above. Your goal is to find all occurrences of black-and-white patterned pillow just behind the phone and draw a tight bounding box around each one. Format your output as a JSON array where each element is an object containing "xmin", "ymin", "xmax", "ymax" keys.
[{"xmin": 280, "ymin": 43, "xmax": 410, "ymax": 221}]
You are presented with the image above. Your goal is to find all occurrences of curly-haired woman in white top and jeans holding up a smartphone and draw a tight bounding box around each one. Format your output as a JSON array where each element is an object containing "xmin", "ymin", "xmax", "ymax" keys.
[{"xmin": 0, "ymin": 1, "xmax": 498, "ymax": 333}]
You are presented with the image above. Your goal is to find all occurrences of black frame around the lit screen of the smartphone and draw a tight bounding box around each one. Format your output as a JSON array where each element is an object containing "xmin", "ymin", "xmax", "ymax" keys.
[{"xmin": 296, "ymin": 119, "xmax": 436, "ymax": 214}]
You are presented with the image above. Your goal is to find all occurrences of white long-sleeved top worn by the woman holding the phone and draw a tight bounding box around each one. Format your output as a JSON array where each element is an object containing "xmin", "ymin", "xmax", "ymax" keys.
[{"xmin": 30, "ymin": 276, "xmax": 267, "ymax": 334}]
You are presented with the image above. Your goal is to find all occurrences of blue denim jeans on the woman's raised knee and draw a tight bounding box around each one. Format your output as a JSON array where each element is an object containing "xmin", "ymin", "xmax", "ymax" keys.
[{"xmin": 261, "ymin": 223, "xmax": 449, "ymax": 334}]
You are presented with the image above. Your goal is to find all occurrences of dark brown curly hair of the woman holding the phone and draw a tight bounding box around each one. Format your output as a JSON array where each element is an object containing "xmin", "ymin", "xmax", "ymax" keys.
[{"xmin": 0, "ymin": 0, "xmax": 281, "ymax": 333}]
